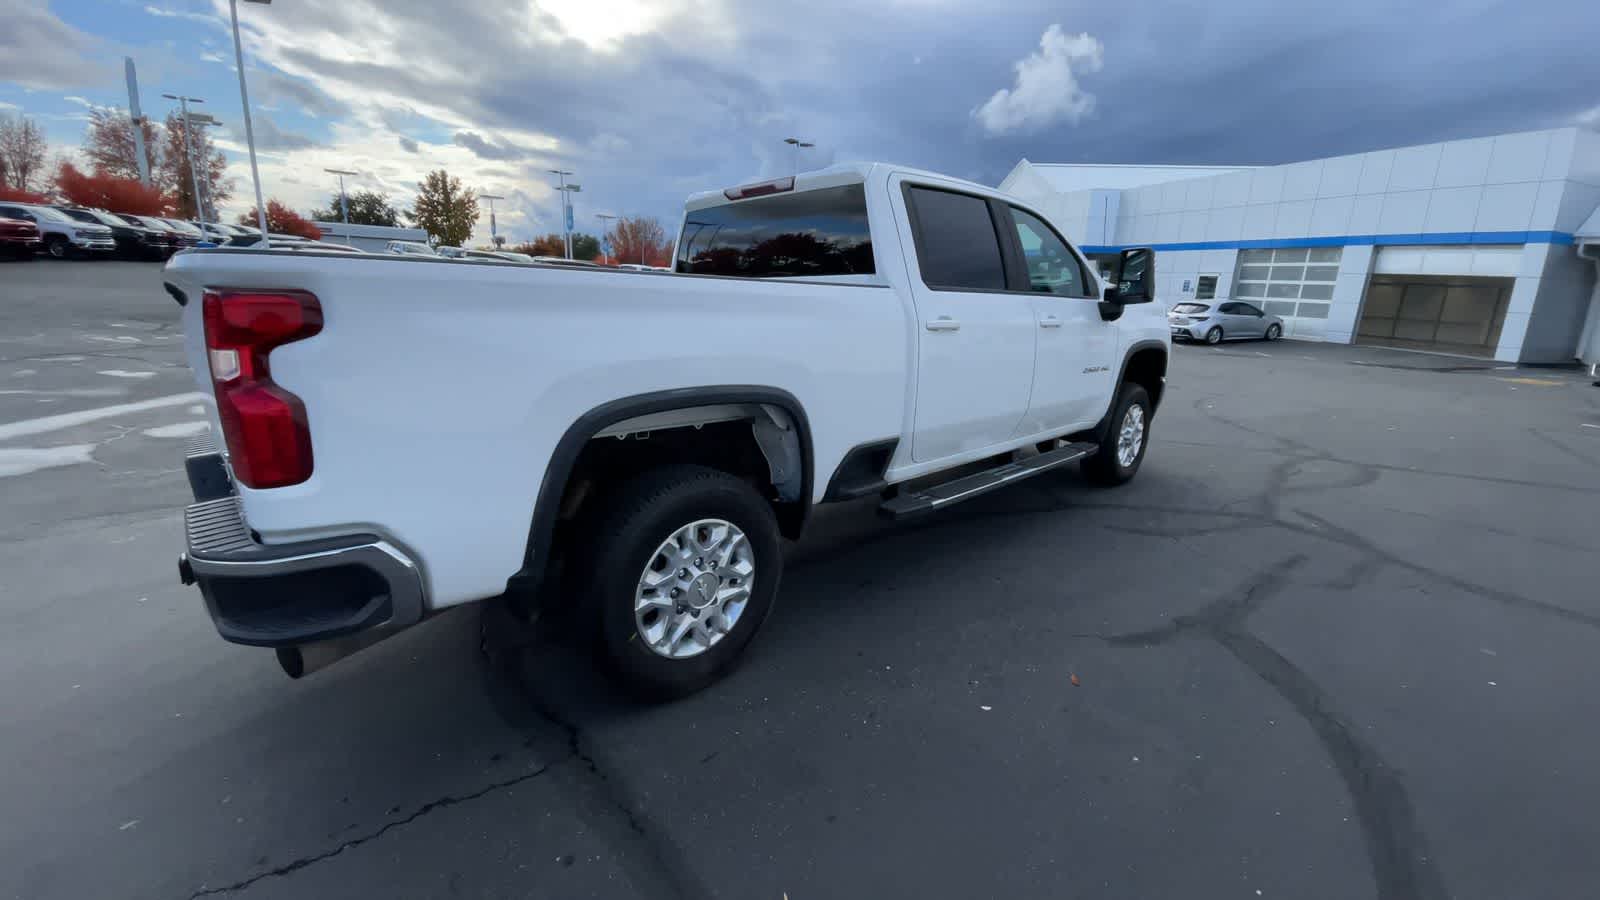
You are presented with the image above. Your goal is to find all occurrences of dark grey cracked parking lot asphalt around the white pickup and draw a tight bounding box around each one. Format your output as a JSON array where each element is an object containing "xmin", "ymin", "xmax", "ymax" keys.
[{"xmin": 0, "ymin": 254, "xmax": 1600, "ymax": 900}]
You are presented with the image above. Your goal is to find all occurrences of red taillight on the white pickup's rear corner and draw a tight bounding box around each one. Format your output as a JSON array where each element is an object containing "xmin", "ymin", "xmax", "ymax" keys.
[{"xmin": 203, "ymin": 291, "xmax": 322, "ymax": 488}]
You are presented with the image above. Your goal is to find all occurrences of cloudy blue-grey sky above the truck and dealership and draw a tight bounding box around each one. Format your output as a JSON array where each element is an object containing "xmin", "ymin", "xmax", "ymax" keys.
[{"xmin": 0, "ymin": 0, "xmax": 1600, "ymax": 239}]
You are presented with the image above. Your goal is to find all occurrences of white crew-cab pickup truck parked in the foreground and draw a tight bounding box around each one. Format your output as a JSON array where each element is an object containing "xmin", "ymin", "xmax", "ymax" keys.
[{"xmin": 163, "ymin": 163, "xmax": 1170, "ymax": 697}]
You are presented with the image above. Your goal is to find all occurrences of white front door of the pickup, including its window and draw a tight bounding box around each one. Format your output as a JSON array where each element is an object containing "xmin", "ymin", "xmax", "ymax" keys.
[{"xmin": 1006, "ymin": 207, "xmax": 1117, "ymax": 437}]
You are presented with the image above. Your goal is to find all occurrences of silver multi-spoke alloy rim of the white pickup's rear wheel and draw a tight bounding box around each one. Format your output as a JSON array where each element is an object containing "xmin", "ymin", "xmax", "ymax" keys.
[{"xmin": 634, "ymin": 519, "xmax": 755, "ymax": 660}]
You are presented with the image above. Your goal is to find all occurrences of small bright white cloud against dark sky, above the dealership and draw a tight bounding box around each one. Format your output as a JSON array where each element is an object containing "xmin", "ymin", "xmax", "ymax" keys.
[{"xmin": 973, "ymin": 26, "xmax": 1106, "ymax": 136}]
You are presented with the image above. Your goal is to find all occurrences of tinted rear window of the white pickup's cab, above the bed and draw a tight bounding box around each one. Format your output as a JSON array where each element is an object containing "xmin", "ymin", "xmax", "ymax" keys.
[{"xmin": 677, "ymin": 184, "xmax": 877, "ymax": 279}]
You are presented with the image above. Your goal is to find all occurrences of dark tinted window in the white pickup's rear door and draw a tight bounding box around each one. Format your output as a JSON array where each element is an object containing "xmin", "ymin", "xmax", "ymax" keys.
[{"xmin": 910, "ymin": 187, "xmax": 1005, "ymax": 290}]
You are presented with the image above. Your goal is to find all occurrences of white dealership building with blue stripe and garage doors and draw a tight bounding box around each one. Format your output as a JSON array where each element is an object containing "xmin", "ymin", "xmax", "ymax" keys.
[{"xmin": 1000, "ymin": 128, "xmax": 1600, "ymax": 364}]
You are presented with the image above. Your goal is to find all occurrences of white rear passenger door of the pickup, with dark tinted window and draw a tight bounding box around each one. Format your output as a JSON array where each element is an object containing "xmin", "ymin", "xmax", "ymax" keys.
[{"xmin": 890, "ymin": 176, "xmax": 1038, "ymax": 463}]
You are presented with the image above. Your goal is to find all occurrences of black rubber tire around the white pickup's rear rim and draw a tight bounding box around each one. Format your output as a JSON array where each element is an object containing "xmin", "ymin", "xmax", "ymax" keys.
[{"xmin": 573, "ymin": 466, "xmax": 782, "ymax": 700}]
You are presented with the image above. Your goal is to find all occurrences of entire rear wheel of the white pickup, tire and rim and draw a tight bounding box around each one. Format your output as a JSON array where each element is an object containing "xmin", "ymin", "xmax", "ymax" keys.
[{"xmin": 587, "ymin": 466, "xmax": 782, "ymax": 700}]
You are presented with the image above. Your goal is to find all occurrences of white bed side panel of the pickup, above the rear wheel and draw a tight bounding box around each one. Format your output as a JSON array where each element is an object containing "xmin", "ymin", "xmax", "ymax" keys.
[{"xmin": 165, "ymin": 250, "xmax": 909, "ymax": 609}]
